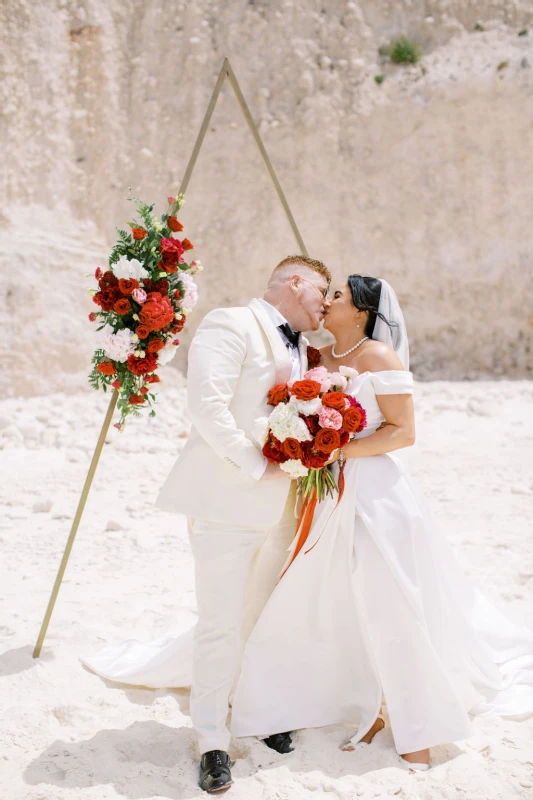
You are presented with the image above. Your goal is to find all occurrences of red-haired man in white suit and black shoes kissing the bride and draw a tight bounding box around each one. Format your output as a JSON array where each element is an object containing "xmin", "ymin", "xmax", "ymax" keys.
[{"xmin": 156, "ymin": 256, "xmax": 331, "ymax": 792}]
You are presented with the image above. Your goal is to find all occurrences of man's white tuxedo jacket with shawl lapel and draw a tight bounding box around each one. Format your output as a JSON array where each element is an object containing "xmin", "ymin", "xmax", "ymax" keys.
[{"xmin": 155, "ymin": 300, "xmax": 308, "ymax": 528}]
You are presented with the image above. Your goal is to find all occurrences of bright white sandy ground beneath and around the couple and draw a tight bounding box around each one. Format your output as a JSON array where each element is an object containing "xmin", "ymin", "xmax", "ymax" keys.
[{"xmin": 0, "ymin": 376, "xmax": 533, "ymax": 800}]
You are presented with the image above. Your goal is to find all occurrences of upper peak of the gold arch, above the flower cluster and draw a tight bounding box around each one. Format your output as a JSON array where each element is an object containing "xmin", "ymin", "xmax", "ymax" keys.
[{"xmin": 180, "ymin": 57, "xmax": 308, "ymax": 256}]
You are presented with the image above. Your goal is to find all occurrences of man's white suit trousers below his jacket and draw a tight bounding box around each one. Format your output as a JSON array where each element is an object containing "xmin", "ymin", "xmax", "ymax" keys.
[{"xmin": 188, "ymin": 482, "xmax": 296, "ymax": 753}]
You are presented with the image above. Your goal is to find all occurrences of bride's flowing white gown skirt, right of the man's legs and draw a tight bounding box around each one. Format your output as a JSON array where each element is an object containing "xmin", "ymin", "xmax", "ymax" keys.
[{"xmin": 231, "ymin": 454, "xmax": 533, "ymax": 753}]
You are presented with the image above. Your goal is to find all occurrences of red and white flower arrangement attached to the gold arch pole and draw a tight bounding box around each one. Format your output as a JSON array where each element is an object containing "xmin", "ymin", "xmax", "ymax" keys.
[{"xmin": 89, "ymin": 195, "xmax": 203, "ymax": 431}]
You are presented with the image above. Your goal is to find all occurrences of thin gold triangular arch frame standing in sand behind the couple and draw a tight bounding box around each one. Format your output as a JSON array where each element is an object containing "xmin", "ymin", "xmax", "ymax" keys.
[{"xmin": 33, "ymin": 58, "xmax": 308, "ymax": 658}]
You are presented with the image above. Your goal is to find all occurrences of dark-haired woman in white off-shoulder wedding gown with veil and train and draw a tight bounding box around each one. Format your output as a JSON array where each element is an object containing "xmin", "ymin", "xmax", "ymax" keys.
[{"xmin": 82, "ymin": 275, "xmax": 533, "ymax": 770}]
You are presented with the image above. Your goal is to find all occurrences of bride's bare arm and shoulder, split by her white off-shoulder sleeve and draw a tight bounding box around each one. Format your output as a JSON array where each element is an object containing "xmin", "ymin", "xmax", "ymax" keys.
[{"xmin": 330, "ymin": 345, "xmax": 415, "ymax": 463}]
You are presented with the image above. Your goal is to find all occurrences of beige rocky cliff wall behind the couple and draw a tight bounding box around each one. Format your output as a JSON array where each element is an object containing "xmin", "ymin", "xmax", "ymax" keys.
[{"xmin": 0, "ymin": 0, "xmax": 533, "ymax": 394}]
